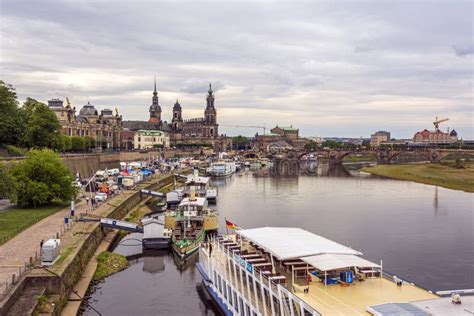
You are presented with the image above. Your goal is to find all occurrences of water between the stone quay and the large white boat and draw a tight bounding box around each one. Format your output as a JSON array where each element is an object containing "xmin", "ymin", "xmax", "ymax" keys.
[{"xmin": 85, "ymin": 233, "xmax": 215, "ymax": 315}]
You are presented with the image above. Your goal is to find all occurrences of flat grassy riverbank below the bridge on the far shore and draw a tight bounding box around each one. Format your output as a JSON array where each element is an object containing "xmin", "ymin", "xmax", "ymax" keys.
[{"xmin": 362, "ymin": 164, "xmax": 474, "ymax": 192}]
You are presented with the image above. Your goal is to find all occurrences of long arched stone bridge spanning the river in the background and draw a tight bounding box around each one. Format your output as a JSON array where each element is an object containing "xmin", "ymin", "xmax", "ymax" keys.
[{"xmin": 269, "ymin": 148, "xmax": 474, "ymax": 164}]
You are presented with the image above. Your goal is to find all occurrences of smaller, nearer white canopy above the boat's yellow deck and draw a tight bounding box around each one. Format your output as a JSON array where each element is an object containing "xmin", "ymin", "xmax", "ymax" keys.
[{"xmin": 301, "ymin": 254, "xmax": 380, "ymax": 271}]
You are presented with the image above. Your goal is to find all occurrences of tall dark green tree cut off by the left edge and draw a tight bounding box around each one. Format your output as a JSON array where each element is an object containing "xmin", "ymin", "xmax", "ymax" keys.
[{"xmin": 0, "ymin": 80, "xmax": 24, "ymax": 146}]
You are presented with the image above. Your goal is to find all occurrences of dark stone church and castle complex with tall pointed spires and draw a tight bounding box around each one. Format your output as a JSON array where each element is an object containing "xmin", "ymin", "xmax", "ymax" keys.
[{"xmin": 123, "ymin": 81, "xmax": 232, "ymax": 151}]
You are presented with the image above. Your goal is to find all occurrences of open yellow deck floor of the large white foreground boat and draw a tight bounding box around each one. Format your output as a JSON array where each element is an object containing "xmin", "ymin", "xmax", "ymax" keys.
[{"xmin": 295, "ymin": 278, "xmax": 438, "ymax": 315}]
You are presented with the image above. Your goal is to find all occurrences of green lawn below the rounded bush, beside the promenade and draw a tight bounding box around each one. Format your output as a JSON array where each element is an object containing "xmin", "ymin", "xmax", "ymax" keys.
[{"xmin": 0, "ymin": 203, "xmax": 68, "ymax": 245}]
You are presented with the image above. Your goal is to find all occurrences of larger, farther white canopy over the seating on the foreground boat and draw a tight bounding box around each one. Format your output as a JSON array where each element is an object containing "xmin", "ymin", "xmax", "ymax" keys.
[{"xmin": 236, "ymin": 227, "xmax": 362, "ymax": 260}]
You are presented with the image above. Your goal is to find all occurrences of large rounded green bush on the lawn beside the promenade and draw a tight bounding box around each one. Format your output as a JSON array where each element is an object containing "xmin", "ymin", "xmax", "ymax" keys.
[{"xmin": 11, "ymin": 149, "xmax": 76, "ymax": 207}]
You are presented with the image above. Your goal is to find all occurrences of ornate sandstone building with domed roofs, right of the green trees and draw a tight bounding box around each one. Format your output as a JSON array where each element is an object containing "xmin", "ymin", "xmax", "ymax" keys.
[{"xmin": 48, "ymin": 98, "xmax": 122, "ymax": 149}]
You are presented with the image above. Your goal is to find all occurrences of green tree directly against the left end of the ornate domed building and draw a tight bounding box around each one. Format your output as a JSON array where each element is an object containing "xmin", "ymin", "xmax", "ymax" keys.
[{"xmin": 23, "ymin": 98, "xmax": 63, "ymax": 150}]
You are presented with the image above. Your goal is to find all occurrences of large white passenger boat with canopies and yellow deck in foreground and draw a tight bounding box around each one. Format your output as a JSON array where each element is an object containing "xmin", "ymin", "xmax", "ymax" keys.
[{"xmin": 197, "ymin": 227, "xmax": 469, "ymax": 316}]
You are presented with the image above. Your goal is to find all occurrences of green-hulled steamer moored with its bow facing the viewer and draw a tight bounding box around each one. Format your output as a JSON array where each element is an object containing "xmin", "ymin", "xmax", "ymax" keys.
[{"xmin": 165, "ymin": 190, "xmax": 219, "ymax": 259}]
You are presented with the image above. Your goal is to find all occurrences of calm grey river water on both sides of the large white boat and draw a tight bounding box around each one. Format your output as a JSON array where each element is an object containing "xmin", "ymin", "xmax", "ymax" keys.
[{"xmin": 85, "ymin": 166, "xmax": 474, "ymax": 315}]
